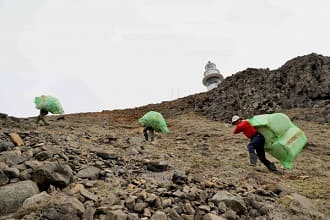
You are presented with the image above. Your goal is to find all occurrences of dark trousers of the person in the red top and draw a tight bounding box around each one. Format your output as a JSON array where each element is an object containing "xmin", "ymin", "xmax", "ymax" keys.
[{"xmin": 247, "ymin": 133, "xmax": 271, "ymax": 168}]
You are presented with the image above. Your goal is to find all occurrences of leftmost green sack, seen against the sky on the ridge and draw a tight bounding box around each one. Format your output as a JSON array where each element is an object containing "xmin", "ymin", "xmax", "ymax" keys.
[{"xmin": 34, "ymin": 95, "xmax": 64, "ymax": 114}]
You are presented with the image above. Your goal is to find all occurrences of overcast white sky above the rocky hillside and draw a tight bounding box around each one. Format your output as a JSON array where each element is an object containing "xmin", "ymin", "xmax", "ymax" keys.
[{"xmin": 0, "ymin": 0, "xmax": 330, "ymax": 117}]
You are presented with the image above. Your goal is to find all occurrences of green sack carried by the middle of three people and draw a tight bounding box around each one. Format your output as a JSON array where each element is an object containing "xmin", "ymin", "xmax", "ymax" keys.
[{"xmin": 139, "ymin": 111, "xmax": 169, "ymax": 133}]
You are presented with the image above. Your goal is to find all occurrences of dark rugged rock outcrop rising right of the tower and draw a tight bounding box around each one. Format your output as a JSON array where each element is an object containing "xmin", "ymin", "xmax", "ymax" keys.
[{"xmin": 193, "ymin": 53, "xmax": 330, "ymax": 122}]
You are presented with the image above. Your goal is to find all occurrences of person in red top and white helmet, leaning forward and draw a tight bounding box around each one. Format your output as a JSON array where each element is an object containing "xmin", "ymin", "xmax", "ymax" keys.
[{"xmin": 231, "ymin": 115, "xmax": 277, "ymax": 172}]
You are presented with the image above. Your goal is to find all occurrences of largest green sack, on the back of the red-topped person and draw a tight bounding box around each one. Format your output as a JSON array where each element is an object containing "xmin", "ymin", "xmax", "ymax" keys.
[{"xmin": 248, "ymin": 113, "xmax": 307, "ymax": 169}]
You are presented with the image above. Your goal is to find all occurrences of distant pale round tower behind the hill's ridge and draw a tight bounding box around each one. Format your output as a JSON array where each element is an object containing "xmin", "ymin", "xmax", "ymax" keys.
[{"xmin": 203, "ymin": 61, "xmax": 223, "ymax": 91}]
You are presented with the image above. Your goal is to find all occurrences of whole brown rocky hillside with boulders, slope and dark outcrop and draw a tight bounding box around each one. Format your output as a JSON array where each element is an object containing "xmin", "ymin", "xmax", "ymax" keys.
[{"xmin": 0, "ymin": 54, "xmax": 330, "ymax": 220}]
